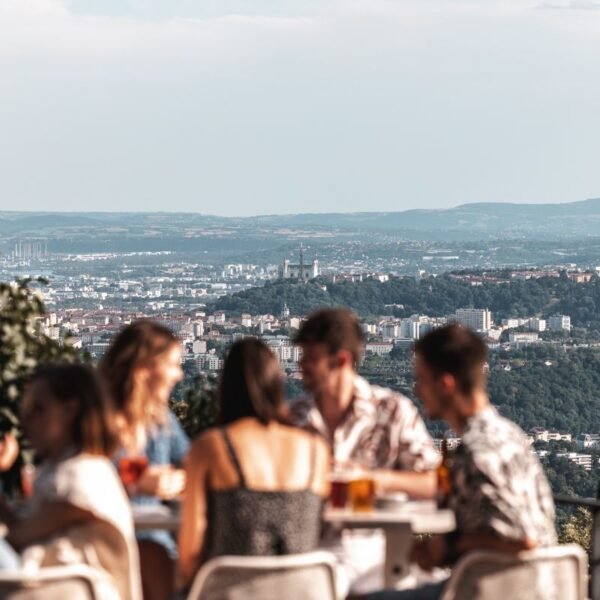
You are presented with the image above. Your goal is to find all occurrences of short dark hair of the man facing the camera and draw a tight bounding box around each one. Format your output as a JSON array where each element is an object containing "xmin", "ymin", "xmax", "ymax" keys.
[{"xmin": 294, "ymin": 308, "xmax": 365, "ymax": 365}]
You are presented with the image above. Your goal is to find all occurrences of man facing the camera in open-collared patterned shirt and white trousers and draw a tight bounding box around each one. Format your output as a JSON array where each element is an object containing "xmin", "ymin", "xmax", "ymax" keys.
[{"xmin": 292, "ymin": 309, "xmax": 439, "ymax": 592}]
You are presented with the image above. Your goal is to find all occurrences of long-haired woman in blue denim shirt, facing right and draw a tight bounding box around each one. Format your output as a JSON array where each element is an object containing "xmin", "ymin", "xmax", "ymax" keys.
[{"xmin": 100, "ymin": 320, "xmax": 189, "ymax": 600}]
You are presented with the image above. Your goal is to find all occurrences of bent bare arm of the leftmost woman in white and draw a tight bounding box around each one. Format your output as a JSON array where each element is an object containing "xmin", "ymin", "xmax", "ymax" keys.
[{"xmin": 7, "ymin": 501, "xmax": 95, "ymax": 549}]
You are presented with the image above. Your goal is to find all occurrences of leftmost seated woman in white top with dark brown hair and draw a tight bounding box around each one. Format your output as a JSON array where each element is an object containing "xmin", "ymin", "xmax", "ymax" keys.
[{"xmin": 0, "ymin": 364, "xmax": 141, "ymax": 600}]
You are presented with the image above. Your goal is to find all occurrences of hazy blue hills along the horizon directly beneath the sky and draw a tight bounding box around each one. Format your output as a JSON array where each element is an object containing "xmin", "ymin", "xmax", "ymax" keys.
[{"xmin": 0, "ymin": 198, "xmax": 600, "ymax": 241}]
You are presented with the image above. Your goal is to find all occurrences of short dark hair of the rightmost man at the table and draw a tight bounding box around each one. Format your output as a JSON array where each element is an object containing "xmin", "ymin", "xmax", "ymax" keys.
[{"xmin": 415, "ymin": 323, "xmax": 488, "ymax": 394}]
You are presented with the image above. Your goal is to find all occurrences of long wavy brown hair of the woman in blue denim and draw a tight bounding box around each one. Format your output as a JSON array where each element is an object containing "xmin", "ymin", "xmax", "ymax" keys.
[{"xmin": 99, "ymin": 319, "xmax": 179, "ymax": 425}]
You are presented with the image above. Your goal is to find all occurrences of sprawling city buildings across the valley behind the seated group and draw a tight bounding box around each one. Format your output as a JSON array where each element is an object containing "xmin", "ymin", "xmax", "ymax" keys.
[{"xmin": 0, "ymin": 232, "xmax": 600, "ymax": 486}]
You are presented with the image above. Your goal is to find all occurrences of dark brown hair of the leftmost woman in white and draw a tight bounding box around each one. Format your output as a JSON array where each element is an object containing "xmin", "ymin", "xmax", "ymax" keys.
[{"xmin": 29, "ymin": 363, "xmax": 118, "ymax": 456}]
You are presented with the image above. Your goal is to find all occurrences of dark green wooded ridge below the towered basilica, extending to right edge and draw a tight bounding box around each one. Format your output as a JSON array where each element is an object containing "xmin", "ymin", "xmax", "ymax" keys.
[{"xmin": 214, "ymin": 274, "xmax": 600, "ymax": 329}]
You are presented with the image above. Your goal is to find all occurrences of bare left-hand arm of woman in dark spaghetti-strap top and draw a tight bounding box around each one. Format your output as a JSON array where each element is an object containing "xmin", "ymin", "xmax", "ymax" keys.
[{"xmin": 179, "ymin": 433, "xmax": 214, "ymax": 586}]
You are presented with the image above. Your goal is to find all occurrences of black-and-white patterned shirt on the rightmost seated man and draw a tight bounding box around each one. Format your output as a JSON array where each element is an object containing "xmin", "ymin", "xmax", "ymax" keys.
[{"xmin": 448, "ymin": 407, "xmax": 556, "ymax": 546}]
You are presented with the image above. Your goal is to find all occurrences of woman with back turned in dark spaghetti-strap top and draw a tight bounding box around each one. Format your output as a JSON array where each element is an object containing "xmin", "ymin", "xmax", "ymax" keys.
[{"xmin": 179, "ymin": 338, "xmax": 330, "ymax": 585}]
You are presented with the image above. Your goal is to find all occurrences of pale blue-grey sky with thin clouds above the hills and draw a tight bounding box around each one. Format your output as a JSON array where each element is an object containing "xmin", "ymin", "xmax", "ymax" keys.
[{"xmin": 0, "ymin": 0, "xmax": 600, "ymax": 216}]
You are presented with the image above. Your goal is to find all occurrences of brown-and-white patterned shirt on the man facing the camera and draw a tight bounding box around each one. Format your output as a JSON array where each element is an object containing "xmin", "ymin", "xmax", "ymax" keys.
[{"xmin": 292, "ymin": 375, "xmax": 439, "ymax": 471}]
